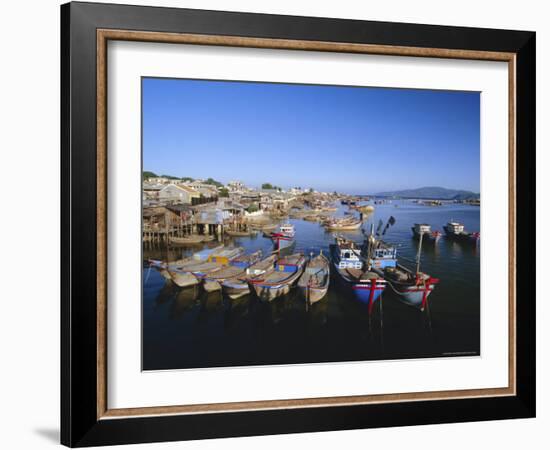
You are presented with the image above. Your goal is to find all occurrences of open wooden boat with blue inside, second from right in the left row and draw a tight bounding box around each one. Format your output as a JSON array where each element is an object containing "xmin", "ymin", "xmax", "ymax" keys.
[{"xmin": 250, "ymin": 253, "xmax": 305, "ymax": 302}]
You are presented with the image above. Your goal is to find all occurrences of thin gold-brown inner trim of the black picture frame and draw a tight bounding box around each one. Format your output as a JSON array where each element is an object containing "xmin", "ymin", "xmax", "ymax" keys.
[{"xmin": 97, "ymin": 29, "xmax": 516, "ymax": 420}]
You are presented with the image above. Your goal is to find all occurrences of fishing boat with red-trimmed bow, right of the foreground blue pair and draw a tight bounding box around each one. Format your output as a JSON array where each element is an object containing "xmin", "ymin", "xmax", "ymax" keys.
[{"xmin": 367, "ymin": 234, "xmax": 439, "ymax": 311}]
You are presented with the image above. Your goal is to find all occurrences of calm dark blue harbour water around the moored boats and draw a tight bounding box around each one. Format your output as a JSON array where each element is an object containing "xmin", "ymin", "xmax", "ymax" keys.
[{"xmin": 143, "ymin": 200, "xmax": 483, "ymax": 370}]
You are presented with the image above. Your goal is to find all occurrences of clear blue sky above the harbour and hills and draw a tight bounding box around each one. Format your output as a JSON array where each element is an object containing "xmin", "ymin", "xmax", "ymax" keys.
[{"xmin": 142, "ymin": 78, "xmax": 480, "ymax": 194}]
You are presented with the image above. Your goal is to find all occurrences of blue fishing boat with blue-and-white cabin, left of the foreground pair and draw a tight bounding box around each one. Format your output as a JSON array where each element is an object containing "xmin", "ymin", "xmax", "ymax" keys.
[{"xmin": 330, "ymin": 237, "xmax": 386, "ymax": 314}]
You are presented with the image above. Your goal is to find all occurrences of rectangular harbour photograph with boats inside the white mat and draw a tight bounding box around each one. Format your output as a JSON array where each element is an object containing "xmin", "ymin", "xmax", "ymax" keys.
[{"xmin": 140, "ymin": 77, "xmax": 480, "ymax": 371}]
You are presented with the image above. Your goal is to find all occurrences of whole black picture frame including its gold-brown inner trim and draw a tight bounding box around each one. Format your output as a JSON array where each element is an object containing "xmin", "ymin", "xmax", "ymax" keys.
[{"xmin": 61, "ymin": 2, "xmax": 536, "ymax": 447}]
